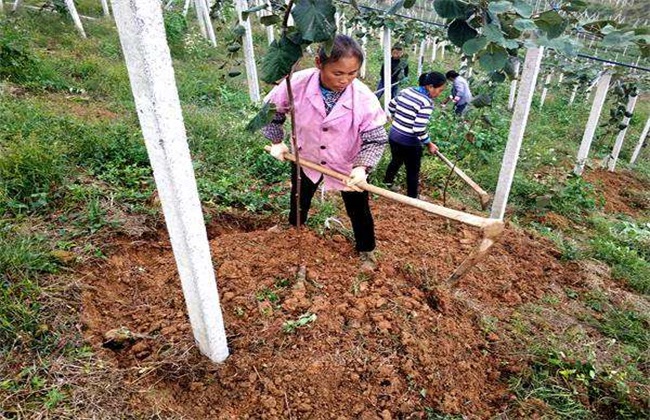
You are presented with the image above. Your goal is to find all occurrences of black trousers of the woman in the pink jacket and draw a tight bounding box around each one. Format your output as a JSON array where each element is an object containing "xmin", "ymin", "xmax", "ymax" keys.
[{"xmin": 289, "ymin": 164, "xmax": 376, "ymax": 252}]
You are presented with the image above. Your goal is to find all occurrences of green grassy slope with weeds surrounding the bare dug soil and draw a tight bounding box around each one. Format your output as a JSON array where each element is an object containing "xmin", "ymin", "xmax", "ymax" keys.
[{"xmin": 0, "ymin": 1, "xmax": 650, "ymax": 417}]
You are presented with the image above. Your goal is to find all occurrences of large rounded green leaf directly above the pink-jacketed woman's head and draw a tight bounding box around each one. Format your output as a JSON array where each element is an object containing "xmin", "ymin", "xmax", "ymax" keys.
[{"xmin": 291, "ymin": 0, "xmax": 336, "ymax": 42}]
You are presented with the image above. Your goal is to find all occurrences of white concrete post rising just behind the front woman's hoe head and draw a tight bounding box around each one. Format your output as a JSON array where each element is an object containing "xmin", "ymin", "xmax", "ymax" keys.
[{"xmin": 490, "ymin": 47, "xmax": 544, "ymax": 220}]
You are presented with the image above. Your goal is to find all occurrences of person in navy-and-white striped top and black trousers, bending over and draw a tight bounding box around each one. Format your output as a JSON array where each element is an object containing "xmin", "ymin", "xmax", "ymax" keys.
[{"xmin": 384, "ymin": 72, "xmax": 447, "ymax": 198}]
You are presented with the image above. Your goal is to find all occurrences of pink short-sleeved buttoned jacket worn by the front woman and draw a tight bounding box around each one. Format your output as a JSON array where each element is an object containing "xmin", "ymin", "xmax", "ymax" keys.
[{"xmin": 264, "ymin": 68, "xmax": 386, "ymax": 190}]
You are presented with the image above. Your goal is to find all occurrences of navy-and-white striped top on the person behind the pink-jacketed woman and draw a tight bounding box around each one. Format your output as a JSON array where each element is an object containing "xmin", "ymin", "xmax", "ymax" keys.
[{"xmin": 388, "ymin": 87, "xmax": 433, "ymax": 146}]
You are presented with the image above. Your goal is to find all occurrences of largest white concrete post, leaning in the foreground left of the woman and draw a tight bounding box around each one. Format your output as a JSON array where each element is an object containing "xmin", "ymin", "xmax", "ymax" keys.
[{"xmin": 107, "ymin": 0, "xmax": 228, "ymax": 362}]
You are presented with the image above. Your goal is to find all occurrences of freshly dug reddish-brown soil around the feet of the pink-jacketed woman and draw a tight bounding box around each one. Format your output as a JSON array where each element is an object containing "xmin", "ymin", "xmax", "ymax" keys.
[{"xmin": 83, "ymin": 195, "xmax": 580, "ymax": 419}]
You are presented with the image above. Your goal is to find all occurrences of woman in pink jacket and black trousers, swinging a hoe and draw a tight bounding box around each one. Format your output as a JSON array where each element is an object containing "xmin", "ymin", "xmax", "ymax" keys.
[{"xmin": 262, "ymin": 35, "xmax": 388, "ymax": 269}]
